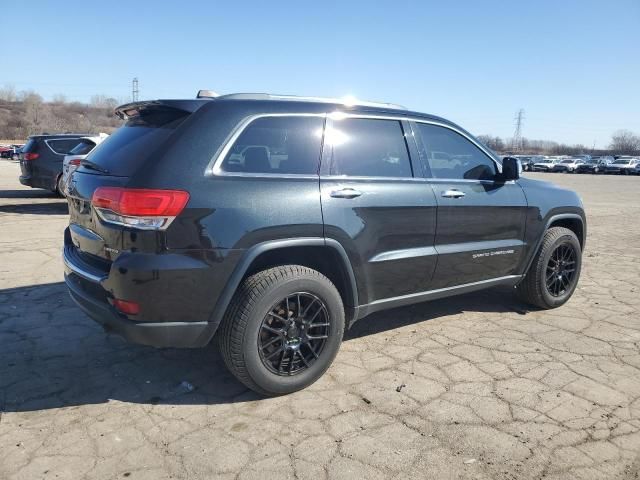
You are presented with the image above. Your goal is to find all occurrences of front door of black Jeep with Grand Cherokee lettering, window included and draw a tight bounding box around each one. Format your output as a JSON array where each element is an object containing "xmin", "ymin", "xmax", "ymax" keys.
[{"xmin": 415, "ymin": 122, "xmax": 527, "ymax": 288}]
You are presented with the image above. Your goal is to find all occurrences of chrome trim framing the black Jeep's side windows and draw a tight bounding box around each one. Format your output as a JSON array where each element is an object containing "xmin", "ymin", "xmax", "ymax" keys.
[{"xmin": 204, "ymin": 111, "xmax": 502, "ymax": 178}]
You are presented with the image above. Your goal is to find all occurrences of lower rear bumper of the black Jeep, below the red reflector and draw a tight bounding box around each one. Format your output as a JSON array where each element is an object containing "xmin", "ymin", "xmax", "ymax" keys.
[{"xmin": 63, "ymin": 249, "xmax": 217, "ymax": 348}]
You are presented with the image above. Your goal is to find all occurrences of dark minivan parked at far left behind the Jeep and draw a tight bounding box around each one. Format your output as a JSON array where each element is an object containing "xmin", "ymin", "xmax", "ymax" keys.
[{"xmin": 20, "ymin": 133, "xmax": 89, "ymax": 195}]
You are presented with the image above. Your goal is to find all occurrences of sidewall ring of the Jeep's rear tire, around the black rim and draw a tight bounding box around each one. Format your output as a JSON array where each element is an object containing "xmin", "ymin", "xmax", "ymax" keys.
[{"xmin": 242, "ymin": 276, "xmax": 344, "ymax": 395}]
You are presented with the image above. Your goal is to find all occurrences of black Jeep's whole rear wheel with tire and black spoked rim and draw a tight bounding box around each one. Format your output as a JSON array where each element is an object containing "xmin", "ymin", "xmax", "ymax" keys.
[{"xmin": 217, "ymin": 265, "xmax": 345, "ymax": 396}]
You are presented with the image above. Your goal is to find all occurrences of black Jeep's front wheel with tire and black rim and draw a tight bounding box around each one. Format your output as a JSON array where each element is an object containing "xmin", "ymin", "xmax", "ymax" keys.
[{"xmin": 516, "ymin": 227, "xmax": 582, "ymax": 309}]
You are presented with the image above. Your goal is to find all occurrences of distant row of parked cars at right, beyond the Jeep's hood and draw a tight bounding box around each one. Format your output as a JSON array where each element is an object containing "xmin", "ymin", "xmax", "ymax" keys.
[{"xmin": 514, "ymin": 155, "xmax": 640, "ymax": 175}]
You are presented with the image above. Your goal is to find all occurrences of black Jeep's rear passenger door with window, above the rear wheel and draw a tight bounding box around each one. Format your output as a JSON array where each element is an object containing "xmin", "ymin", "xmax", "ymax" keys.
[{"xmin": 320, "ymin": 116, "xmax": 436, "ymax": 305}]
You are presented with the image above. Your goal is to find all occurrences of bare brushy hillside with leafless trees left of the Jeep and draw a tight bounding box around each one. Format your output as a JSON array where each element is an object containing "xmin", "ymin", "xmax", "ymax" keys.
[{"xmin": 0, "ymin": 86, "xmax": 124, "ymax": 141}]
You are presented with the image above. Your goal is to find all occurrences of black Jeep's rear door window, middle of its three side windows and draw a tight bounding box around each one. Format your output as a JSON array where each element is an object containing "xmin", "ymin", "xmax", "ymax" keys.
[{"xmin": 325, "ymin": 118, "xmax": 412, "ymax": 177}]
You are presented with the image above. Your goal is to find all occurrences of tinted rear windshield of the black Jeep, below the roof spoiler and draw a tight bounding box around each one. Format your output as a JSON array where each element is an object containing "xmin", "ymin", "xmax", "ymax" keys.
[{"xmin": 81, "ymin": 108, "xmax": 189, "ymax": 176}]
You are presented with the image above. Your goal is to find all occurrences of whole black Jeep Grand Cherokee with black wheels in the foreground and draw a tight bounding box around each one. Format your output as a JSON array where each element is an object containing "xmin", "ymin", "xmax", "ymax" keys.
[{"xmin": 64, "ymin": 94, "xmax": 586, "ymax": 395}]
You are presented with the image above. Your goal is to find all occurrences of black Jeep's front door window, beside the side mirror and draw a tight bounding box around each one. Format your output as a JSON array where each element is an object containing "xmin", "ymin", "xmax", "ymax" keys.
[{"xmin": 417, "ymin": 123, "xmax": 496, "ymax": 180}]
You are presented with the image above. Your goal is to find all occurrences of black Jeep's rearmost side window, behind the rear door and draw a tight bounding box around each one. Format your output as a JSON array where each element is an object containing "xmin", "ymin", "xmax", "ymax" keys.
[{"xmin": 222, "ymin": 116, "xmax": 324, "ymax": 175}]
